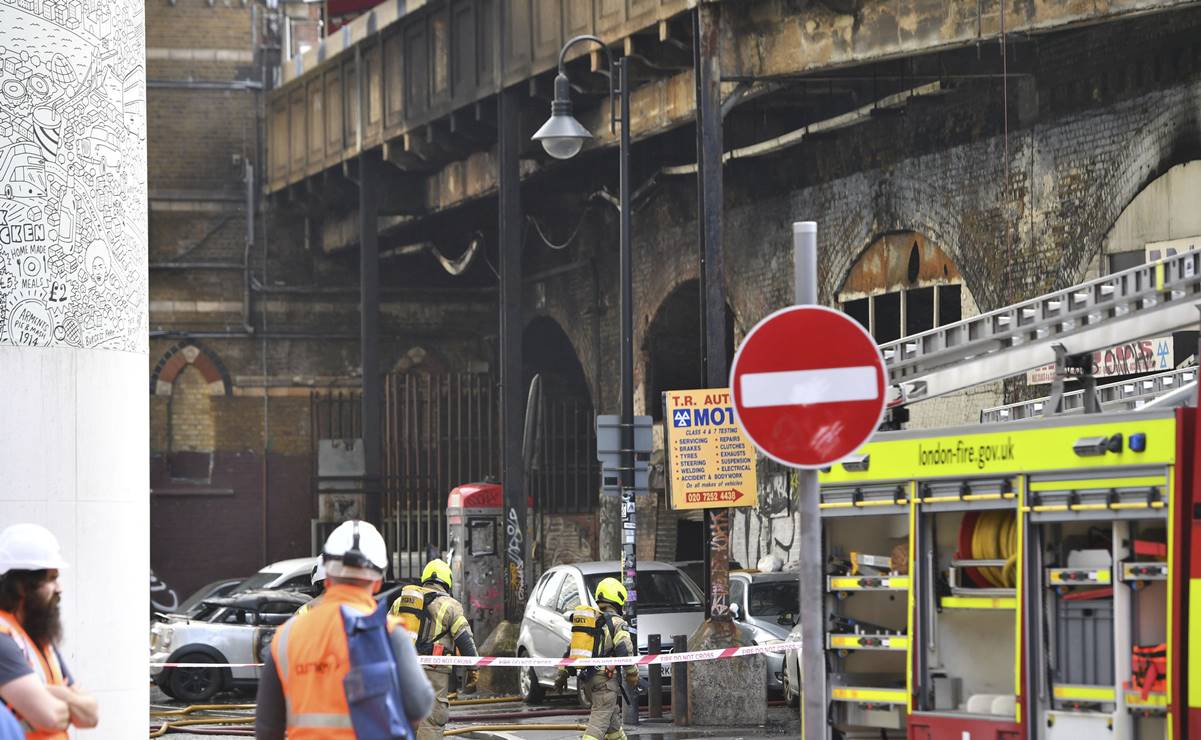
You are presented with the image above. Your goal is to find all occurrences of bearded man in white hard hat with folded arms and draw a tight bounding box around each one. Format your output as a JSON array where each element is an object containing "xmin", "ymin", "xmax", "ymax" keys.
[{"xmin": 0, "ymin": 524, "xmax": 97, "ymax": 740}]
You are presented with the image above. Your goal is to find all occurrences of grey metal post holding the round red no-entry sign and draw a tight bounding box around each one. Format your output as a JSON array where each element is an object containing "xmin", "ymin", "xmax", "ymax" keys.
[{"xmin": 793, "ymin": 221, "xmax": 826, "ymax": 740}]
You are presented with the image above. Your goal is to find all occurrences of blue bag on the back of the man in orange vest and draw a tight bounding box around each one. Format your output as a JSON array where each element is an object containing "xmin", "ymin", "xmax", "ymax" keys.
[{"xmin": 341, "ymin": 605, "xmax": 412, "ymax": 740}]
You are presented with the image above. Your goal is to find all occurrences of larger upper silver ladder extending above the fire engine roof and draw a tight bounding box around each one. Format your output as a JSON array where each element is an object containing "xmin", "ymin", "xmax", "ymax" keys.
[{"xmin": 880, "ymin": 250, "xmax": 1201, "ymax": 413}]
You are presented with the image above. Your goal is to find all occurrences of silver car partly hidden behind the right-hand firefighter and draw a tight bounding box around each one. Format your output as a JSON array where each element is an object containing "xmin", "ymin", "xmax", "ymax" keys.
[{"xmin": 518, "ymin": 561, "xmax": 705, "ymax": 703}]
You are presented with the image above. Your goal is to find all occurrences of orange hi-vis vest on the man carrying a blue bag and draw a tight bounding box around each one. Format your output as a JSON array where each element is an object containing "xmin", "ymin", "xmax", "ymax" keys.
[{"xmin": 271, "ymin": 584, "xmax": 399, "ymax": 740}]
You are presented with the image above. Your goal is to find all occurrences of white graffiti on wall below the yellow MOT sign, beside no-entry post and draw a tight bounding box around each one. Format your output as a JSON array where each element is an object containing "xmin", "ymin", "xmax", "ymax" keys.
[{"xmin": 730, "ymin": 461, "xmax": 801, "ymax": 567}]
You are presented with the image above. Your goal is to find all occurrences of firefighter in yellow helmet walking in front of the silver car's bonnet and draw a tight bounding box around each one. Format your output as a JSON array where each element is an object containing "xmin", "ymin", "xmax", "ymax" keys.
[{"xmin": 555, "ymin": 578, "xmax": 638, "ymax": 740}]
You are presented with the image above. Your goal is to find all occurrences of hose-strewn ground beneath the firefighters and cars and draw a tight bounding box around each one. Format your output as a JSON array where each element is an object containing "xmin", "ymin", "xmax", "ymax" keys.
[{"xmin": 150, "ymin": 686, "xmax": 801, "ymax": 740}]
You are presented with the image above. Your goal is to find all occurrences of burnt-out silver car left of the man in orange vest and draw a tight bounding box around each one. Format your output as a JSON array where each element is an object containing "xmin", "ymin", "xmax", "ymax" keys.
[{"xmin": 150, "ymin": 589, "xmax": 311, "ymax": 703}]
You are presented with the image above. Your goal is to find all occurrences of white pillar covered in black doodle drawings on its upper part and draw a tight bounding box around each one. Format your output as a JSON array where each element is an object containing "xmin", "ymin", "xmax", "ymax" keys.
[{"xmin": 0, "ymin": 0, "xmax": 150, "ymax": 739}]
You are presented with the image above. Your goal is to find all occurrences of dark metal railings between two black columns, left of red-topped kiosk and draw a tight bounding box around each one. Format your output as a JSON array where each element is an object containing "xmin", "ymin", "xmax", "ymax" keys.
[{"xmin": 382, "ymin": 372, "xmax": 501, "ymax": 578}]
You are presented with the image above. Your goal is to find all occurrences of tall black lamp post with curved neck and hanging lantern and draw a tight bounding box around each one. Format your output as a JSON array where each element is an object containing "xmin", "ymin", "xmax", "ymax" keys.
[{"xmin": 533, "ymin": 35, "xmax": 638, "ymax": 717}]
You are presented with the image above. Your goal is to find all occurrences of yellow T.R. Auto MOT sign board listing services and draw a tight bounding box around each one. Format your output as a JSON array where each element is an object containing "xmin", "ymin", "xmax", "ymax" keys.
[{"xmin": 663, "ymin": 388, "xmax": 759, "ymax": 509}]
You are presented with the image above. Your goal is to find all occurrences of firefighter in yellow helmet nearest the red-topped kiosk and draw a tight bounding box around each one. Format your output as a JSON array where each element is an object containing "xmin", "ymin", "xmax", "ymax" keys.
[{"xmin": 392, "ymin": 560, "xmax": 479, "ymax": 740}]
